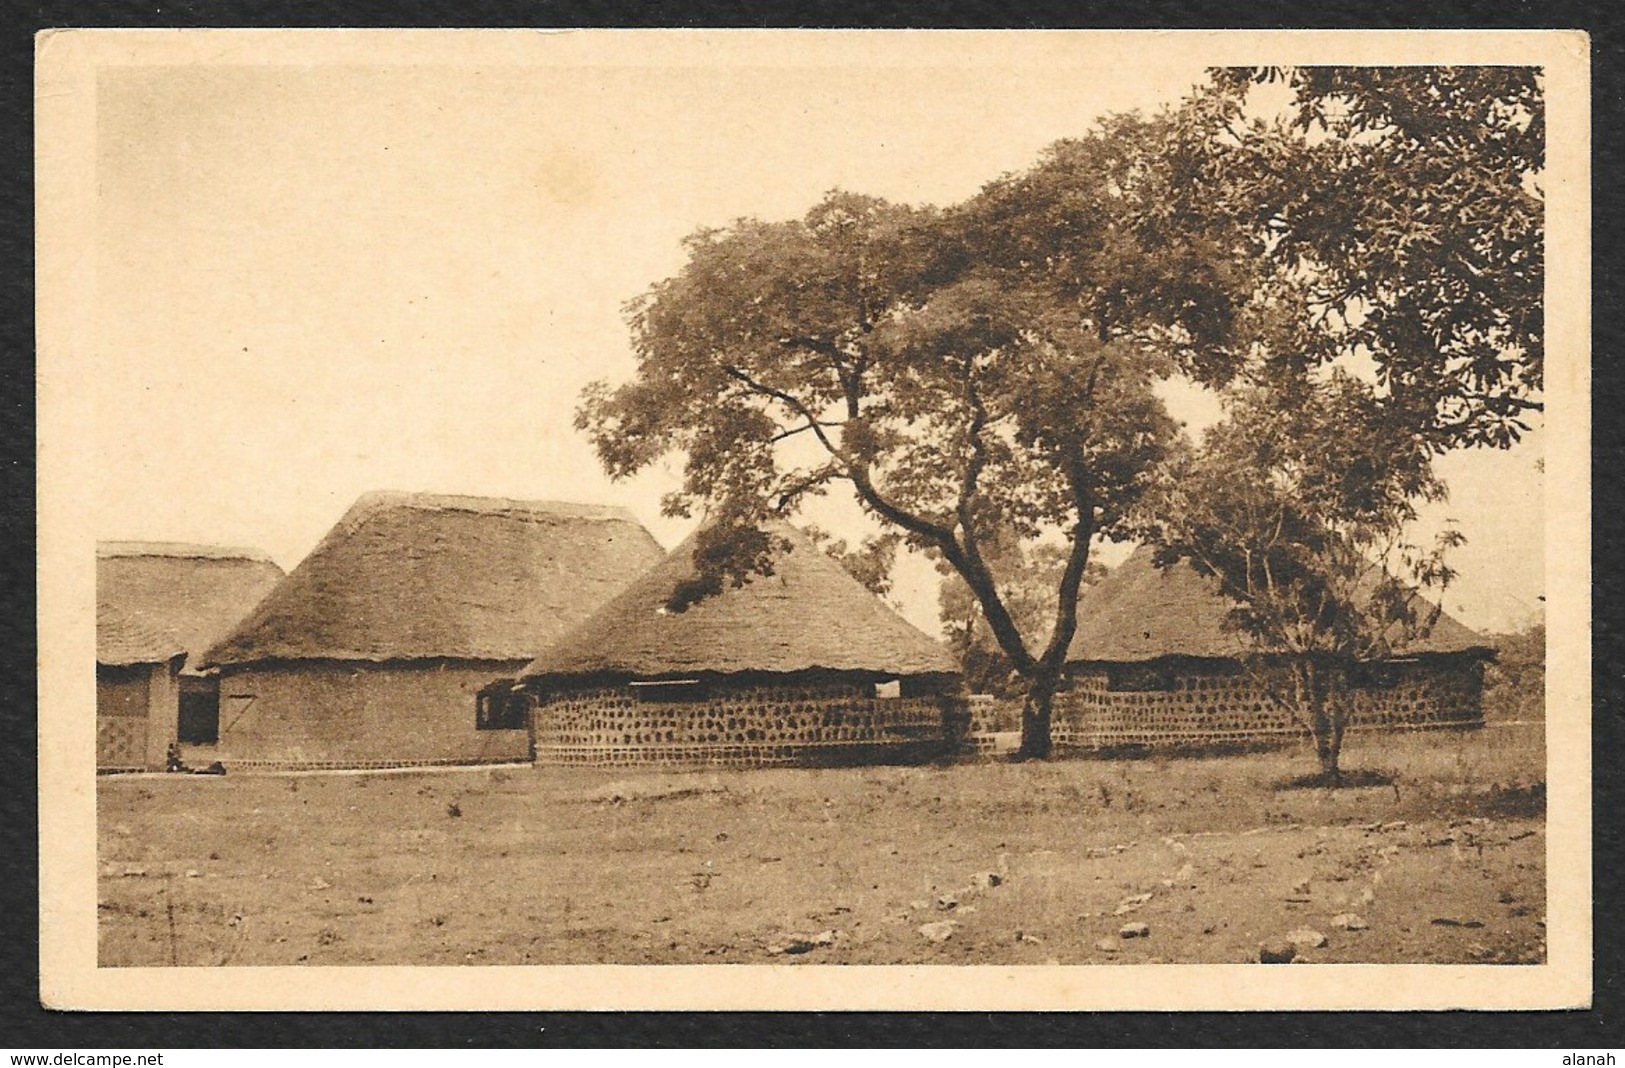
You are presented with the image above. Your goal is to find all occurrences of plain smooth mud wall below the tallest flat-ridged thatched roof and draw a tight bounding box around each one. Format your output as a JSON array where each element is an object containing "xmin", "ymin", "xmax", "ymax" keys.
[{"xmin": 215, "ymin": 660, "xmax": 530, "ymax": 771}]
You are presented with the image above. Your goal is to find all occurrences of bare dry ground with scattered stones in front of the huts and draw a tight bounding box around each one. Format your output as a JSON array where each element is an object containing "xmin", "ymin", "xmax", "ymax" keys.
[{"xmin": 99, "ymin": 727, "xmax": 1545, "ymax": 966}]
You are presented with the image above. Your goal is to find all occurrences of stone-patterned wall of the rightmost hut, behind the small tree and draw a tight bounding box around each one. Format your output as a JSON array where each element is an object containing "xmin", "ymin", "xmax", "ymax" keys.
[{"xmin": 1051, "ymin": 657, "xmax": 1484, "ymax": 749}]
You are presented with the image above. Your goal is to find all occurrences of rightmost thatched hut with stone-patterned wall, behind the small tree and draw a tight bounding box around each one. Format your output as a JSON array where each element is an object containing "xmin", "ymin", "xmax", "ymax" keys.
[{"xmin": 1051, "ymin": 548, "xmax": 1495, "ymax": 751}]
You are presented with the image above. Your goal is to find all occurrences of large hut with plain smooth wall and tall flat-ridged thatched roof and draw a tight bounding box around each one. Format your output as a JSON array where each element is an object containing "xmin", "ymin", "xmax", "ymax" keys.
[{"xmin": 196, "ymin": 493, "xmax": 661, "ymax": 769}]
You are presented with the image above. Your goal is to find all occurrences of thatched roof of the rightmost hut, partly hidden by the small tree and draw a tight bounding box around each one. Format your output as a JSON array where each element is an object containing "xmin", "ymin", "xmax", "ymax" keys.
[{"xmin": 1066, "ymin": 546, "xmax": 1492, "ymax": 663}]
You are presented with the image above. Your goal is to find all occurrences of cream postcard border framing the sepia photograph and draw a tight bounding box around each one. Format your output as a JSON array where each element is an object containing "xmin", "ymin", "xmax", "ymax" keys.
[{"xmin": 36, "ymin": 29, "xmax": 1593, "ymax": 1011}]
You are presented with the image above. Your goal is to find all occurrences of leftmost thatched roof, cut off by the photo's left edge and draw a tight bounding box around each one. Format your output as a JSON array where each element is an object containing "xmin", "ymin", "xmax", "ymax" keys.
[{"xmin": 96, "ymin": 541, "xmax": 283, "ymax": 671}]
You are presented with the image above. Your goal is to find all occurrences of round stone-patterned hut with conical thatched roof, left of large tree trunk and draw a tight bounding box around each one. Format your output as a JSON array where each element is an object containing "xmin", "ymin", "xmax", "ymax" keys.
[{"xmin": 522, "ymin": 523, "xmax": 964, "ymax": 767}]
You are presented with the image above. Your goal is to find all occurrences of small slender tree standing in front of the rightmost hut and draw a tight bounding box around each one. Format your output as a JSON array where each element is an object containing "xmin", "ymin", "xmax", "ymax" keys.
[{"xmin": 1144, "ymin": 374, "xmax": 1461, "ymax": 784}]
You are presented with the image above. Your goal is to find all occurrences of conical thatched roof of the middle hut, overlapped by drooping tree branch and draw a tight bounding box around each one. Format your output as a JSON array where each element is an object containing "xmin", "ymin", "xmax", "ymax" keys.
[{"xmin": 523, "ymin": 523, "xmax": 959, "ymax": 678}]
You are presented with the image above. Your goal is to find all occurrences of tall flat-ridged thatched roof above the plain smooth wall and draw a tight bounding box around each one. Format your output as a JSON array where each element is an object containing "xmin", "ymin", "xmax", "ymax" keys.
[{"xmin": 206, "ymin": 493, "xmax": 661, "ymax": 663}]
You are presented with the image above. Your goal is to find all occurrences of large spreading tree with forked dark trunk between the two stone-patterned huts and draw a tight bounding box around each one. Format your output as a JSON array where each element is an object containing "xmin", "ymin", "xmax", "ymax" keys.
[{"xmin": 579, "ymin": 119, "xmax": 1237, "ymax": 756}]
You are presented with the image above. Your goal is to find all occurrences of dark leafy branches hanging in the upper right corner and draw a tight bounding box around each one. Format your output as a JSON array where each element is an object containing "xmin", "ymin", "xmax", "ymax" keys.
[{"xmin": 1185, "ymin": 67, "xmax": 1545, "ymax": 450}]
